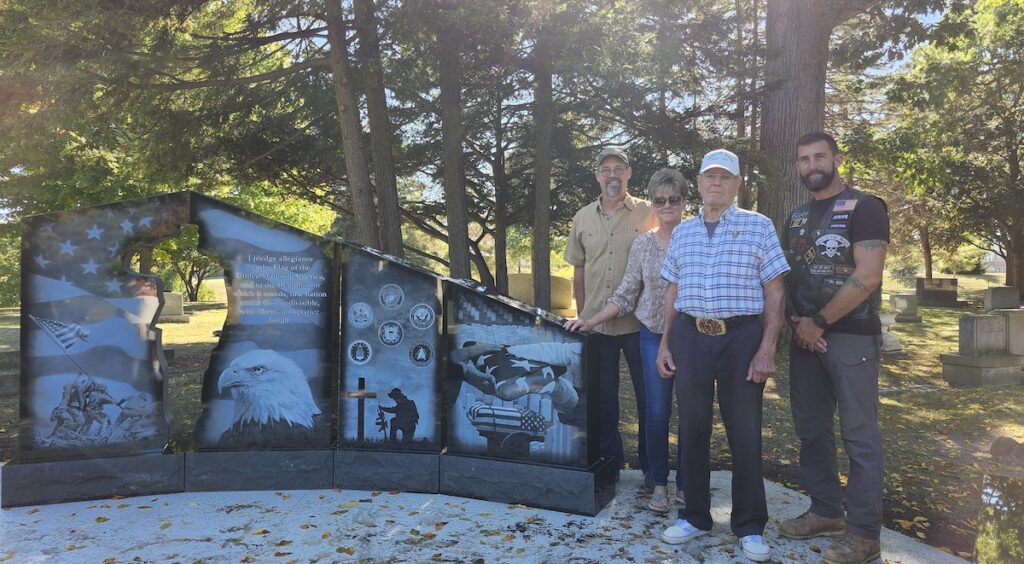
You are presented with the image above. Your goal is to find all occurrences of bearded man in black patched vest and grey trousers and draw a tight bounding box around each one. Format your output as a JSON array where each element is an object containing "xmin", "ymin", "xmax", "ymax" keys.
[{"xmin": 779, "ymin": 132, "xmax": 889, "ymax": 564}]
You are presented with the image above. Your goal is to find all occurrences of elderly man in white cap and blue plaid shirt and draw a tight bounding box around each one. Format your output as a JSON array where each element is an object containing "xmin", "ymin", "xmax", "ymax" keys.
[{"xmin": 657, "ymin": 149, "xmax": 790, "ymax": 562}]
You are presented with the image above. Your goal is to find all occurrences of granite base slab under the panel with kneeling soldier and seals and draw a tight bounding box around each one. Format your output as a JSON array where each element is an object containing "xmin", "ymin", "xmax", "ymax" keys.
[{"xmin": 334, "ymin": 450, "xmax": 440, "ymax": 493}]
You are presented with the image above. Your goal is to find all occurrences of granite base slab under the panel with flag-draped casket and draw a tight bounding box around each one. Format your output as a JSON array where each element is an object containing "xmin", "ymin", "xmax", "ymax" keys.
[{"xmin": 440, "ymin": 453, "xmax": 615, "ymax": 516}]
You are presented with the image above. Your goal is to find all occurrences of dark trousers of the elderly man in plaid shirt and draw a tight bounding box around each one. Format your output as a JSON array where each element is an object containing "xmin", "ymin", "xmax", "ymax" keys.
[{"xmin": 669, "ymin": 317, "xmax": 768, "ymax": 536}]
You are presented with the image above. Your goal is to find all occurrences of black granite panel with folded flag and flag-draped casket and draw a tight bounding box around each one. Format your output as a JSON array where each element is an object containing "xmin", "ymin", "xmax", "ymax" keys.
[{"xmin": 445, "ymin": 280, "xmax": 593, "ymax": 468}]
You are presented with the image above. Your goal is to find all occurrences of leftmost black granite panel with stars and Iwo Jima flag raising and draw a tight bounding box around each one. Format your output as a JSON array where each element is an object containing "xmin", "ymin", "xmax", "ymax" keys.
[{"xmin": 20, "ymin": 194, "xmax": 187, "ymax": 460}]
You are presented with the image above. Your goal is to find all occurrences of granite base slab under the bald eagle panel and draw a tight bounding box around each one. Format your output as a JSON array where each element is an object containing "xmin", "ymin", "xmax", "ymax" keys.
[{"xmin": 185, "ymin": 450, "xmax": 334, "ymax": 491}]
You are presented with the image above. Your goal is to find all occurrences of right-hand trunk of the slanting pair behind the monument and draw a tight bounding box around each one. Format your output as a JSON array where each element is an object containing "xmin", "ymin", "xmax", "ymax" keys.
[{"xmin": 352, "ymin": 0, "xmax": 404, "ymax": 257}]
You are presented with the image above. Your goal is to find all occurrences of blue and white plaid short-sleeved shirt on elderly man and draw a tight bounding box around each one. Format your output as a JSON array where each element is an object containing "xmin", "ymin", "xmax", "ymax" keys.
[{"xmin": 662, "ymin": 205, "xmax": 790, "ymax": 319}]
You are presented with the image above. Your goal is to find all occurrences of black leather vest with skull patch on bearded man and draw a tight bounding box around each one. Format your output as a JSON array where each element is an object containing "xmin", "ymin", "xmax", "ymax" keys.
[{"xmin": 785, "ymin": 186, "xmax": 882, "ymax": 322}]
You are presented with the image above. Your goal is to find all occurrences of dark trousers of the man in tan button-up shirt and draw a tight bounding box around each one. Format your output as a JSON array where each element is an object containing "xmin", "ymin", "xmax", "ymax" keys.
[{"xmin": 587, "ymin": 333, "xmax": 647, "ymax": 472}]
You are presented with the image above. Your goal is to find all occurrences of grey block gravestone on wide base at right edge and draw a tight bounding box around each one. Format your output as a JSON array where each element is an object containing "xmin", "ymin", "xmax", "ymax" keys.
[{"xmin": 939, "ymin": 314, "xmax": 1024, "ymax": 387}]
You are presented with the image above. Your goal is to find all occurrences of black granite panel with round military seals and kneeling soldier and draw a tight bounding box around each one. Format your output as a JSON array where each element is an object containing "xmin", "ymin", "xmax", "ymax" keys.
[{"xmin": 338, "ymin": 245, "xmax": 444, "ymax": 452}]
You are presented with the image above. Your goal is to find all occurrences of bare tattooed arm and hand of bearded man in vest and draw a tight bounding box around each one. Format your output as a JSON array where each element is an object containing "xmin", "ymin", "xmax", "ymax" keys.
[{"xmin": 794, "ymin": 240, "xmax": 889, "ymax": 352}]
